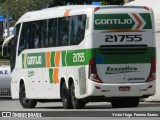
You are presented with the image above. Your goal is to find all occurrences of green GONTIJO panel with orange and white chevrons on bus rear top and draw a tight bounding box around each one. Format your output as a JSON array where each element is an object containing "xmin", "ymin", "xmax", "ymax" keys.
[{"xmin": 94, "ymin": 13, "xmax": 152, "ymax": 30}]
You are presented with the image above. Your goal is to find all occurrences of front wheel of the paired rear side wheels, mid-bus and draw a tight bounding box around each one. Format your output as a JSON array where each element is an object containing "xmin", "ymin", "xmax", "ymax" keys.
[{"xmin": 61, "ymin": 82, "xmax": 73, "ymax": 109}]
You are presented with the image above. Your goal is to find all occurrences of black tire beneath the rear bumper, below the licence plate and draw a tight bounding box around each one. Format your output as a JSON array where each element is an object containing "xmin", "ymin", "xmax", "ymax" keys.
[{"xmin": 111, "ymin": 98, "xmax": 139, "ymax": 108}]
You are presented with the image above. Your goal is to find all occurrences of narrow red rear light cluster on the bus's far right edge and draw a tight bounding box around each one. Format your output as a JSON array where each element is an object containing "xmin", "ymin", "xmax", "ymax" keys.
[{"xmin": 147, "ymin": 57, "xmax": 156, "ymax": 82}]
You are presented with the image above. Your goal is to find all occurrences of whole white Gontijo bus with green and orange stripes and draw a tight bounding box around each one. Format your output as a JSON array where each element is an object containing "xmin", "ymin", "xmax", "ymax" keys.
[{"xmin": 4, "ymin": 5, "xmax": 156, "ymax": 109}]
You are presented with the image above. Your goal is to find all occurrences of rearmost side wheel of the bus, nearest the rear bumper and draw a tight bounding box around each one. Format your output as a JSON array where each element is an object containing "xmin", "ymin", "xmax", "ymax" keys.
[{"xmin": 70, "ymin": 84, "xmax": 86, "ymax": 109}]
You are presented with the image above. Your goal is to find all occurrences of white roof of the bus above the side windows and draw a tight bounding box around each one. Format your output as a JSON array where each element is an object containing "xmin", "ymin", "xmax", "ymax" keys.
[{"xmin": 16, "ymin": 5, "xmax": 149, "ymax": 24}]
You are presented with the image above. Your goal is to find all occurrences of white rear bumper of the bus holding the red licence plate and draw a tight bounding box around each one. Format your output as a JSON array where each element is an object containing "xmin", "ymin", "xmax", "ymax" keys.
[{"xmin": 87, "ymin": 80, "xmax": 155, "ymax": 98}]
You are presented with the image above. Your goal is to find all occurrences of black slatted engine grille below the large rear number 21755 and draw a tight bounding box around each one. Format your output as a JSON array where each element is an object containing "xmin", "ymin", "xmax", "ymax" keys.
[{"xmin": 99, "ymin": 45, "xmax": 148, "ymax": 54}]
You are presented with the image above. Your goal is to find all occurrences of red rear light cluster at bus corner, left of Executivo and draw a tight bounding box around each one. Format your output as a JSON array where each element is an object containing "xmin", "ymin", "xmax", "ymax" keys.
[{"xmin": 88, "ymin": 59, "xmax": 102, "ymax": 83}]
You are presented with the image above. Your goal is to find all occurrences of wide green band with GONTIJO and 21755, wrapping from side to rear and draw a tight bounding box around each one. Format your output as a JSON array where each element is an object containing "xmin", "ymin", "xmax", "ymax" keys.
[{"xmin": 22, "ymin": 47, "xmax": 155, "ymax": 68}]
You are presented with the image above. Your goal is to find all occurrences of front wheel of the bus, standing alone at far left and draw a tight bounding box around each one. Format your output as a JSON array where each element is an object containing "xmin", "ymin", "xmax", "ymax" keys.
[{"xmin": 19, "ymin": 84, "xmax": 37, "ymax": 108}]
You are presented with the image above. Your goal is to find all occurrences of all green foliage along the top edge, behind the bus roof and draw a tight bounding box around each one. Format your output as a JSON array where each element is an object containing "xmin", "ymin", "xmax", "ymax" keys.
[{"xmin": 0, "ymin": 0, "xmax": 123, "ymax": 23}]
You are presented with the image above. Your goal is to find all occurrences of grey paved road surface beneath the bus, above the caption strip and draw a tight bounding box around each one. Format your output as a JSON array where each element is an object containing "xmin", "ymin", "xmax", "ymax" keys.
[{"xmin": 0, "ymin": 100, "xmax": 160, "ymax": 111}]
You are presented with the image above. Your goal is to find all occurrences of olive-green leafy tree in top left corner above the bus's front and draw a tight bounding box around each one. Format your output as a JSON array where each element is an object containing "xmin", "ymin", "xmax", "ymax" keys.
[{"xmin": 0, "ymin": 0, "xmax": 54, "ymax": 21}]
